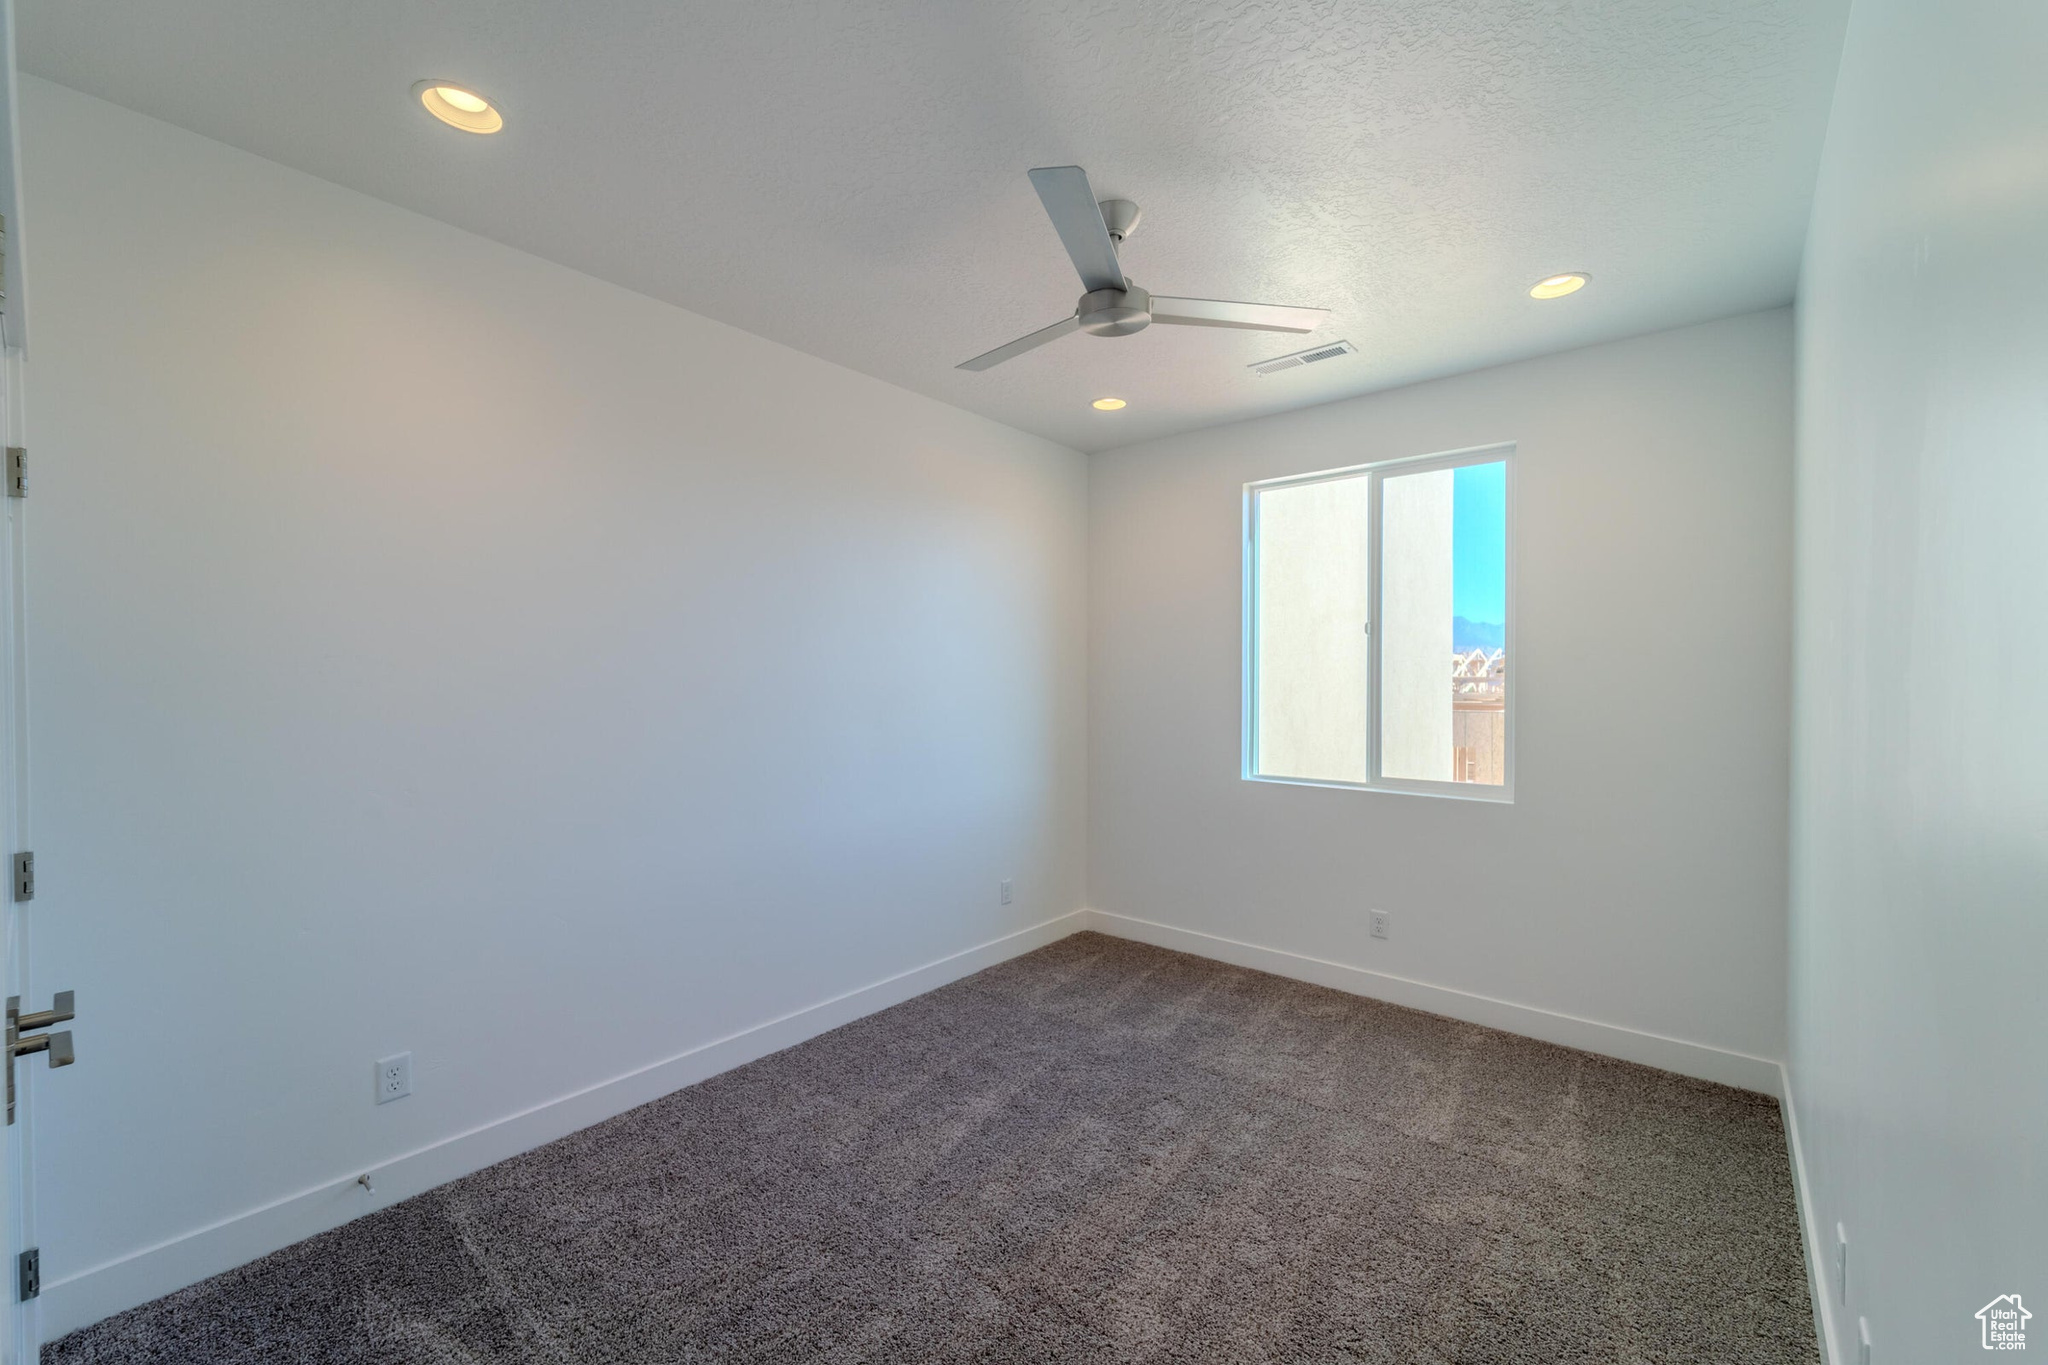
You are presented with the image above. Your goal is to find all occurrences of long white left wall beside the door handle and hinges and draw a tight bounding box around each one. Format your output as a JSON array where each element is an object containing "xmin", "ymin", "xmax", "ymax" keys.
[{"xmin": 23, "ymin": 80, "xmax": 1085, "ymax": 1330}]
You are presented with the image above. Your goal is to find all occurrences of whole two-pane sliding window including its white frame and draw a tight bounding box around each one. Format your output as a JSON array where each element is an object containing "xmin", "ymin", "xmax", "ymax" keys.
[{"xmin": 1245, "ymin": 446, "xmax": 1513, "ymax": 800}]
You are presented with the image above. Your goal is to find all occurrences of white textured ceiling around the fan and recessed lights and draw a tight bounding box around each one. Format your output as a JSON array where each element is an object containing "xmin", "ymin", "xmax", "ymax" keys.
[{"xmin": 16, "ymin": 0, "xmax": 1847, "ymax": 450}]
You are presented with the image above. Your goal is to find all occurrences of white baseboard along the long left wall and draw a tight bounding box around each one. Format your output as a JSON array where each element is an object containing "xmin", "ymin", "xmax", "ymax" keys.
[{"xmin": 37, "ymin": 911, "xmax": 1085, "ymax": 1340}]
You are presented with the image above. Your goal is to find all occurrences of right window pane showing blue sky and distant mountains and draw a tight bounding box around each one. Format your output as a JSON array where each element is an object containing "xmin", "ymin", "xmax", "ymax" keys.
[{"xmin": 1380, "ymin": 463, "xmax": 1507, "ymax": 786}]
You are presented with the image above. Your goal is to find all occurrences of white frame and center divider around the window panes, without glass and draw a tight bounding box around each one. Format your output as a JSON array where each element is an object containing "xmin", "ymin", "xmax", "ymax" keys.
[{"xmin": 1241, "ymin": 442, "xmax": 1522, "ymax": 802}]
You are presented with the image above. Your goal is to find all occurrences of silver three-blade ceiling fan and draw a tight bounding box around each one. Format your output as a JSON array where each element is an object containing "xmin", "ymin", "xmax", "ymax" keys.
[{"xmin": 956, "ymin": 166, "xmax": 1329, "ymax": 370}]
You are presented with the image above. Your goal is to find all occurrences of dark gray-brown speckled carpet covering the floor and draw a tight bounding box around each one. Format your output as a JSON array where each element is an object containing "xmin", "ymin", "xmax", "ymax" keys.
[{"xmin": 43, "ymin": 933, "xmax": 1817, "ymax": 1365}]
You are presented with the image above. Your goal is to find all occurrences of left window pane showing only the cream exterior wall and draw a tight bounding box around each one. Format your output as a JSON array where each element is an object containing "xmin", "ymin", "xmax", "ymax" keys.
[{"xmin": 1253, "ymin": 477, "xmax": 1370, "ymax": 782}]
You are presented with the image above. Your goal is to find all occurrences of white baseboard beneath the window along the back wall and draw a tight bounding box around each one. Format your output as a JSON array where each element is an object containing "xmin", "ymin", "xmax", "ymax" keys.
[{"xmin": 1081, "ymin": 911, "xmax": 1780, "ymax": 1097}]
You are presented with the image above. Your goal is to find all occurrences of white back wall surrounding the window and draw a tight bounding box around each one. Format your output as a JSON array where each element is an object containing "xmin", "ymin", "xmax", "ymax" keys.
[{"xmin": 1087, "ymin": 315, "xmax": 1792, "ymax": 1076}]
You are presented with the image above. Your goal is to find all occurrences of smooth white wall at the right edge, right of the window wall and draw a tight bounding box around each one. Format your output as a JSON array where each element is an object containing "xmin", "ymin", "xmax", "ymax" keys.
[{"xmin": 1790, "ymin": 0, "xmax": 2048, "ymax": 1365}]
